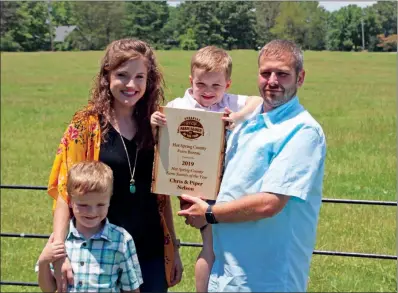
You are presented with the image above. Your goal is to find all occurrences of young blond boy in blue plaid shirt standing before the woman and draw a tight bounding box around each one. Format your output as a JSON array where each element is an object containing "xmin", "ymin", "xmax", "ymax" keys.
[{"xmin": 36, "ymin": 161, "xmax": 143, "ymax": 292}]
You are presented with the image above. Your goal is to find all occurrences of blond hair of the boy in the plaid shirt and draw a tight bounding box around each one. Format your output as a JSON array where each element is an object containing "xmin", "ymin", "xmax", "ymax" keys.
[{"xmin": 66, "ymin": 161, "xmax": 113, "ymax": 197}]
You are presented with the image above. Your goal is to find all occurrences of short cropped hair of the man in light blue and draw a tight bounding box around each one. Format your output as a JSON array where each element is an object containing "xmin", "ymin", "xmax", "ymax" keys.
[{"xmin": 258, "ymin": 40, "xmax": 304, "ymax": 73}]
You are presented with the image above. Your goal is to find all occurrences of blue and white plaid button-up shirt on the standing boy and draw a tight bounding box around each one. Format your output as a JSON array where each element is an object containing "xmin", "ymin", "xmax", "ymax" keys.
[{"xmin": 37, "ymin": 219, "xmax": 143, "ymax": 292}]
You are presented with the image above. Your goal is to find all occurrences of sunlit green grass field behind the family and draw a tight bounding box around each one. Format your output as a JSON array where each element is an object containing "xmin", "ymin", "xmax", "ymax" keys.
[{"xmin": 0, "ymin": 51, "xmax": 397, "ymax": 292}]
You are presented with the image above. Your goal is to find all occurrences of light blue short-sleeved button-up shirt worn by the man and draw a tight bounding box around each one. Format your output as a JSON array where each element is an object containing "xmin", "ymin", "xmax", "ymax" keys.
[{"xmin": 209, "ymin": 97, "xmax": 326, "ymax": 292}]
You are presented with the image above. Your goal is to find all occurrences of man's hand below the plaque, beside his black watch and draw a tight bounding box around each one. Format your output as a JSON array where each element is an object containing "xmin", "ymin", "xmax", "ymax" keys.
[{"xmin": 177, "ymin": 194, "xmax": 209, "ymax": 229}]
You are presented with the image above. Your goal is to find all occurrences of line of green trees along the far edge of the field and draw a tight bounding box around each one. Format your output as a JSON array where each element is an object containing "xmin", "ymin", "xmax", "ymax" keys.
[{"xmin": 0, "ymin": 1, "xmax": 397, "ymax": 51}]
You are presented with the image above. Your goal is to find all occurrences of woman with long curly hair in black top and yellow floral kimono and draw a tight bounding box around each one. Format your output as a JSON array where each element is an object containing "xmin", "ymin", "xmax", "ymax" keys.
[{"xmin": 48, "ymin": 39, "xmax": 182, "ymax": 292}]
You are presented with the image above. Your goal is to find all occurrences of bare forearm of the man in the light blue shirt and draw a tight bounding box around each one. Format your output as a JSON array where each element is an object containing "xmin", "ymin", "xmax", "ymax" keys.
[{"xmin": 213, "ymin": 192, "xmax": 289, "ymax": 223}]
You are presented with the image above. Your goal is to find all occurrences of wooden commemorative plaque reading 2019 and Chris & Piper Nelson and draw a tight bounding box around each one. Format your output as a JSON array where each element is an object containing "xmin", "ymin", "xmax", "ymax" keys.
[{"xmin": 152, "ymin": 107, "xmax": 225, "ymax": 200}]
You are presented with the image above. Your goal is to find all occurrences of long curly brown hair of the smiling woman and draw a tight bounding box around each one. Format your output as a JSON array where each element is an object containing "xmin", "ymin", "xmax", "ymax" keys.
[{"xmin": 76, "ymin": 39, "xmax": 165, "ymax": 148}]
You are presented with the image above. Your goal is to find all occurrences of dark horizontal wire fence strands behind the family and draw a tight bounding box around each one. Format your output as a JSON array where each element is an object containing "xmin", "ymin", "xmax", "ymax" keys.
[{"xmin": 0, "ymin": 185, "xmax": 398, "ymax": 287}]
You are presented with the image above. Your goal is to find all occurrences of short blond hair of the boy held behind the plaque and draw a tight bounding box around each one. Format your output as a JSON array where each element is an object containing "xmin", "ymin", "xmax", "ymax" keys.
[{"xmin": 191, "ymin": 46, "xmax": 232, "ymax": 80}]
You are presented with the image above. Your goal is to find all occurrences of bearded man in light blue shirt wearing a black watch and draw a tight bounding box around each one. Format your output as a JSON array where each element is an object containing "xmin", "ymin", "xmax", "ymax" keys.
[{"xmin": 179, "ymin": 40, "xmax": 326, "ymax": 292}]
